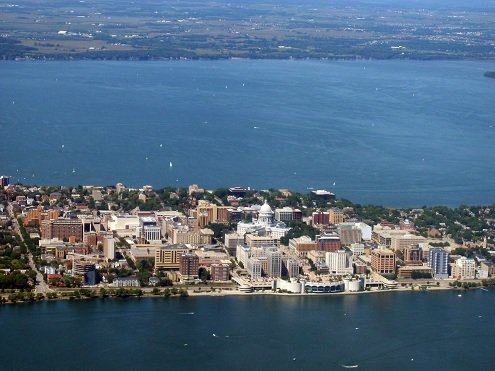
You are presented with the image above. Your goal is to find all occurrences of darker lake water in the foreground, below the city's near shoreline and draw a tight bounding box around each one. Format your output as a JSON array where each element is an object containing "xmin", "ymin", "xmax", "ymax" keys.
[{"xmin": 0, "ymin": 289, "xmax": 495, "ymax": 370}]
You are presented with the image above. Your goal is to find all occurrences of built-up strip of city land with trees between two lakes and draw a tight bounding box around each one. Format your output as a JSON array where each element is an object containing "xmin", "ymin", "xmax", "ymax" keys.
[{"xmin": 0, "ymin": 176, "xmax": 495, "ymax": 302}]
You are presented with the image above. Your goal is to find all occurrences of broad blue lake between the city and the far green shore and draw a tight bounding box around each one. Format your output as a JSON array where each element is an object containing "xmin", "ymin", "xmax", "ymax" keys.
[{"xmin": 0, "ymin": 60, "xmax": 495, "ymax": 206}]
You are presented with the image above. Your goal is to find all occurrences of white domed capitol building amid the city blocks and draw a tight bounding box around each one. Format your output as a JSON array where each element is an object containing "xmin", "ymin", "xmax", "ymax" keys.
[{"xmin": 237, "ymin": 200, "xmax": 290, "ymax": 238}]
